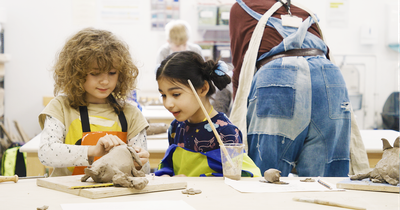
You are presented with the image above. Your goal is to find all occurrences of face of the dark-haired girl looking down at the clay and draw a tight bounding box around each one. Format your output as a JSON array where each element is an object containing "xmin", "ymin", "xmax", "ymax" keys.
[{"xmin": 157, "ymin": 78, "xmax": 204, "ymax": 123}]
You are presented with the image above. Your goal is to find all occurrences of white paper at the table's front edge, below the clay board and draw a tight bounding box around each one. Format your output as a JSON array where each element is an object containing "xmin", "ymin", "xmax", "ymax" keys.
[{"xmin": 61, "ymin": 200, "xmax": 195, "ymax": 210}]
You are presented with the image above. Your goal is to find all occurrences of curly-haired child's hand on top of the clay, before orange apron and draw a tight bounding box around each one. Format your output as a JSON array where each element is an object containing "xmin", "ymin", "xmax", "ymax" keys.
[{"xmin": 88, "ymin": 134, "xmax": 125, "ymax": 157}]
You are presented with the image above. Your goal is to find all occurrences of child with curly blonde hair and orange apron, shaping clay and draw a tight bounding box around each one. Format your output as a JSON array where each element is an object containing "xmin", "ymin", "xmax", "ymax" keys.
[{"xmin": 38, "ymin": 28, "xmax": 150, "ymax": 176}]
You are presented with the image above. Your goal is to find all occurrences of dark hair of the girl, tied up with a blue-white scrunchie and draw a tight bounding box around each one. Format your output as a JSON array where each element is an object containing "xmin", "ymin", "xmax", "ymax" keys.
[{"xmin": 156, "ymin": 51, "xmax": 231, "ymax": 96}]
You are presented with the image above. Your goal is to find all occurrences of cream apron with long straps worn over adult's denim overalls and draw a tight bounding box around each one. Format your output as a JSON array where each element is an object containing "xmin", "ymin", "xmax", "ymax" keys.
[{"xmin": 230, "ymin": 0, "xmax": 368, "ymax": 173}]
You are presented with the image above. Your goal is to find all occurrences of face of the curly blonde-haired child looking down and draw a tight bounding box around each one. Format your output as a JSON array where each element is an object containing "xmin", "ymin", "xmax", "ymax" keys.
[{"xmin": 83, "ymin": 65, "xmax": 119, "ymax": 104}]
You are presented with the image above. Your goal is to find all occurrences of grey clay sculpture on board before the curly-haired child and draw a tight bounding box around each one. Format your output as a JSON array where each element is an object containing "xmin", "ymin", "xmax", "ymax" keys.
[{"xmin": 81, "ymin": 145, "xmax": 149, "ymax": 190}]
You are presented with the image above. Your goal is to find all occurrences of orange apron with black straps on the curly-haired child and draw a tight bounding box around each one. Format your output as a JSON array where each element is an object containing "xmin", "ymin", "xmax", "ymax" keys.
[{"xmin": 72, "ymin": 106, "xmax": 128, "ymax": 175}]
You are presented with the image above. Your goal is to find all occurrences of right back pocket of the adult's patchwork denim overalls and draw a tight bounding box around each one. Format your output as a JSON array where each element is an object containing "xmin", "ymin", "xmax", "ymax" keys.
[{"xmin": 322, "ymin": 64, "xmax": 351, "ymax": 119}]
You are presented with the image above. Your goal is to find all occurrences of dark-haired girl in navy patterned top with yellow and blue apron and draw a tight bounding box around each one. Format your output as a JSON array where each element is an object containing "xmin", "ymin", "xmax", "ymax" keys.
[{"xmin": 156, "ymin": 51, "xmax": 260, "ymax": 176}]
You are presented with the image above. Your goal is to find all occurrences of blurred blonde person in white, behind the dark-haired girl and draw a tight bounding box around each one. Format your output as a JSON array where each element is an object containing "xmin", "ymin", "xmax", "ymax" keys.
[{"xmin": 156, "ymin": 20, "xmax": 204, "ymax": 64}]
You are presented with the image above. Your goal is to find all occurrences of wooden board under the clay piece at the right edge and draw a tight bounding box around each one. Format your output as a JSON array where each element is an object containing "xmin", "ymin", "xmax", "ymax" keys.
[{"xmin": 336, "ymin": 178, "xmax": 400, "ymax": 193}]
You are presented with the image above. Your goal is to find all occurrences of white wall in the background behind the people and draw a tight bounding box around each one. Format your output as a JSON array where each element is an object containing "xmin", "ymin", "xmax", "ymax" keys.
[{"xmin": 0, "ymin": 0, "xmax": 399, "ymax": 137}]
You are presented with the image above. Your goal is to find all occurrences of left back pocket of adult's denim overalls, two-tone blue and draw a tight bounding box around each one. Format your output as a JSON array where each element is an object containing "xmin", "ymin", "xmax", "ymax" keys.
[{"xmin": 256, "ymin": 66, "xmax": 297, "ymax": 119}]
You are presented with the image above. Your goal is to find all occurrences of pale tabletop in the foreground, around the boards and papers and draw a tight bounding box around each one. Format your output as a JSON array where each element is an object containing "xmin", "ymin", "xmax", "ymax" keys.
[{"xmin": 0, "ymin": 177, "xmax": 400, "ymax": 210}]
